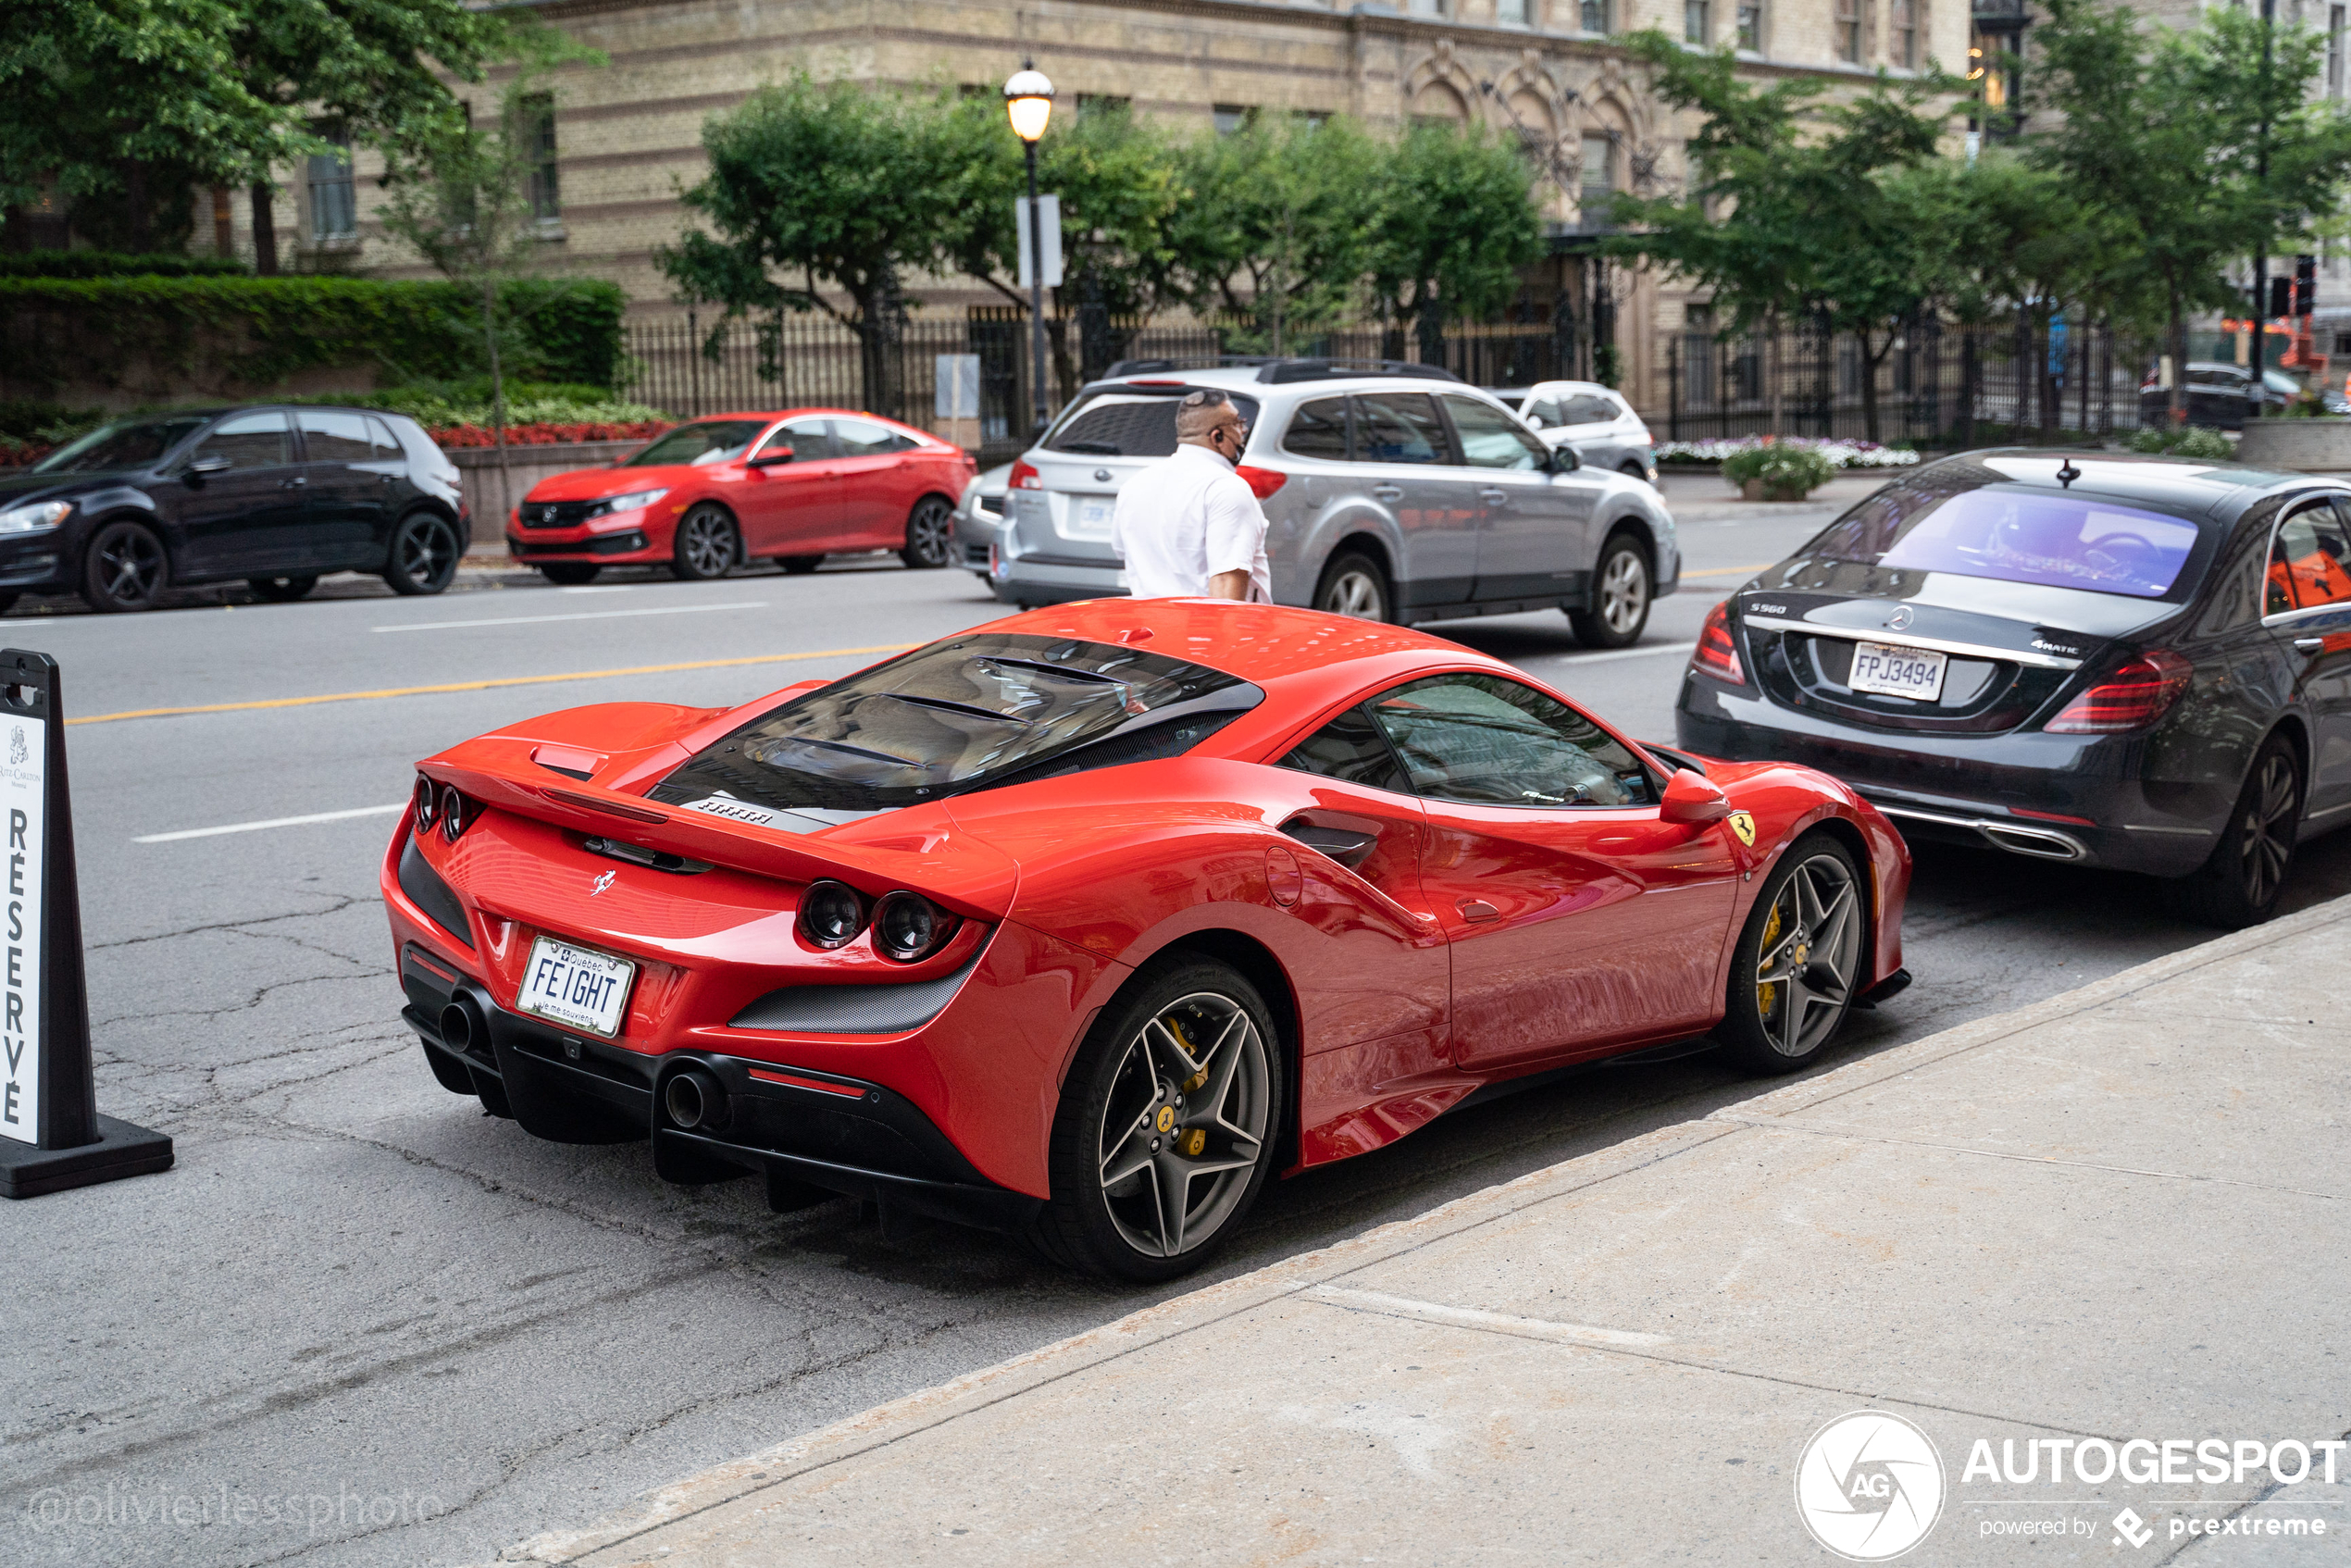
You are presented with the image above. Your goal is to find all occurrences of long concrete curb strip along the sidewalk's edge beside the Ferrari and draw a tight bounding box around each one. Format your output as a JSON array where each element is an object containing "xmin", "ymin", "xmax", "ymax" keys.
[{"xmin": 498, "ymin": 896, "xmax": 2351, "ymax": 1563}]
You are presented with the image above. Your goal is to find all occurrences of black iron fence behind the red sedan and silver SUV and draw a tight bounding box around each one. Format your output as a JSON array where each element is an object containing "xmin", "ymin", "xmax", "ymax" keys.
[{"xmin": 628, "ymin": 305, "xmax": 1573, "ymax": 463}]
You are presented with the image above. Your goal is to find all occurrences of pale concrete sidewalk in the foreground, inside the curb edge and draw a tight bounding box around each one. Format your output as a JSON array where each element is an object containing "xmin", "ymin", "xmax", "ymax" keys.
[{"xmin": 505, "ymin": 898, "xmax": 2351, "ymax": 1565}]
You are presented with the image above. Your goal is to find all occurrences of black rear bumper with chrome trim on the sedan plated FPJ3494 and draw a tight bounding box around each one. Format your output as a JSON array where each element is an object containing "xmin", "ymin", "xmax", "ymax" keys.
[{"xmin": 1673, "ymin": 675, "xmax": 2238, "ymax": 877}]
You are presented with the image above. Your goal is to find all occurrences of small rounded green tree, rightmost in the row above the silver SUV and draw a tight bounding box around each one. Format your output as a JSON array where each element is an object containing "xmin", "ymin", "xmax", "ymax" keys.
[{"xmin": 1368, "ymin": 125, "xmax": 1542, "ymax": 357}]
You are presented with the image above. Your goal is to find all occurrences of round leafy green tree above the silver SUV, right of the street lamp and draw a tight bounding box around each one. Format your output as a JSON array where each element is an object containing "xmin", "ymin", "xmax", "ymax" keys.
[{"xmin": 1166, "ymin": 115, "xmax": 1380, "ymax": 353}]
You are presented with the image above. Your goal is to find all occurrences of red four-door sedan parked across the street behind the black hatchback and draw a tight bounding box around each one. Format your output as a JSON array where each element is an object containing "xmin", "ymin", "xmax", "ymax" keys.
[{"xmin": 505, "ymin": 409, "xmax": 978, "ymax": 583}]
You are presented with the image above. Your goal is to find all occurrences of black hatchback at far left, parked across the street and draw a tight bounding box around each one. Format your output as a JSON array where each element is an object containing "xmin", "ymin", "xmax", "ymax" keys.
[{"xmin": 0, "ymin": 406, "xmax": 470, "ymax": 611}]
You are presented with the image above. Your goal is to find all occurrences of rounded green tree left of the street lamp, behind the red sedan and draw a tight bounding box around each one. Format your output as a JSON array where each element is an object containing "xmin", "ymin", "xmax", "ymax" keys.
[{"xmin": 653, "ymin": 75, "xmax": 982, "ymax": 411}]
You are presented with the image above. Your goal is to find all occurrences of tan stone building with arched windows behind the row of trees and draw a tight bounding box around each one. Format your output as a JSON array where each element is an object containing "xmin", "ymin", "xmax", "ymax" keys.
[{"xmin": 200, "ymin": 0, "xmax": 1971, "ymax": 411}]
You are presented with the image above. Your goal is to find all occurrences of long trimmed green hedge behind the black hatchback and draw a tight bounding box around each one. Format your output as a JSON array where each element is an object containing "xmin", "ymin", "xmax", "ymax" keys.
[{"xmin": 0, "ymin": 276, "xmax": 628, "ymax": 397}]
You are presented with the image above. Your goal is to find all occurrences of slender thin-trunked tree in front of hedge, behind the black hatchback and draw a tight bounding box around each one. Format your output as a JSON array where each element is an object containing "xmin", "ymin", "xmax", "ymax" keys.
[{"xmin": 380, "ymin": 28, "xmax": 604, "ymax": 515}]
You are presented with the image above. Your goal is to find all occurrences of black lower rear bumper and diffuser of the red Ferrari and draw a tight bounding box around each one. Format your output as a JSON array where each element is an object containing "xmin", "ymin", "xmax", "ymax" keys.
[{"xmin": 400, "ymin": 945, "xmax": 1041, "ymax": 1229}]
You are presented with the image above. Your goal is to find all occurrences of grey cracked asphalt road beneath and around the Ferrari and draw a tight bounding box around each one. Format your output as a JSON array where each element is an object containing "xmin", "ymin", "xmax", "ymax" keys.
[{"xmin": 0, "ymin": 481, "xmax": 2351, "ymax": 1563}]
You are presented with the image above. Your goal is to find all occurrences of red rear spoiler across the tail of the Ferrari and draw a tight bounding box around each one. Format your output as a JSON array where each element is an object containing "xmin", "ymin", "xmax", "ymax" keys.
[{"xmin": 418, "ymin": 736, "xmax": 1020, "ymax": 922}]
